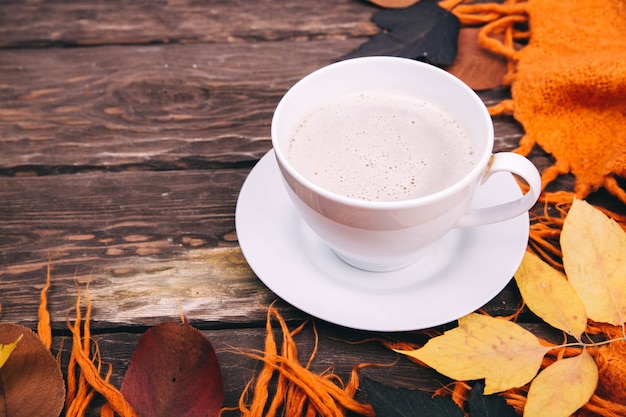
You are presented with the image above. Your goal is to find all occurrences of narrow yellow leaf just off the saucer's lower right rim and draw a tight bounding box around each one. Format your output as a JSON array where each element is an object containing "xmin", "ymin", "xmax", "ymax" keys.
[{"xmin": 515, "ymin": 252, "xmax": 587, "ymax": 340}]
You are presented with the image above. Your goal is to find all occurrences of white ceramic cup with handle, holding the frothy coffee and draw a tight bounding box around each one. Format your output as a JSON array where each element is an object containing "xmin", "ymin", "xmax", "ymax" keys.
[{"xmin": 271, "ymin": 57, "xmax": 541, "ymax": 271}]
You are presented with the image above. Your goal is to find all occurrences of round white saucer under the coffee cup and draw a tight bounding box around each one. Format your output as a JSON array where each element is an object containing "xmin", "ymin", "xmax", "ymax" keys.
[{"xmin": 235, "ymin": 151, "xmax": 529, "ymax": 331}]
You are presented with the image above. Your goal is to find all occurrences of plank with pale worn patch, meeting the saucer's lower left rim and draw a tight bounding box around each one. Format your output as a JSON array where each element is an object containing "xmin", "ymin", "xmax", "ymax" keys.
[{"xmin": 0, "ymin": 255, "xmax": 534, "ymax": 329}]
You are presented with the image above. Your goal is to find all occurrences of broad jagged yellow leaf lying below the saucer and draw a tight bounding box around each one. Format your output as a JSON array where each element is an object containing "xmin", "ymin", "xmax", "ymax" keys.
[{"xmin": 397, "ymin": 313, "xmax": 550, "ymax": 394}]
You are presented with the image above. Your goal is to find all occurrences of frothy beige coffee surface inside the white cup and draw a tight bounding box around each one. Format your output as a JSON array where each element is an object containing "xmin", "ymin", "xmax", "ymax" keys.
[{"xmin": 287, "ymin": 91, "xmax": 476, "ymax": 201}]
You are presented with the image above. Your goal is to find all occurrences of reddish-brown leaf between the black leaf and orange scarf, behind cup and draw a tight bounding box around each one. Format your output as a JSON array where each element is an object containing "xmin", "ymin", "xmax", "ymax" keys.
[{"xmin": 446, "ymin": 28, "xmax": 507, "ymax": 90}]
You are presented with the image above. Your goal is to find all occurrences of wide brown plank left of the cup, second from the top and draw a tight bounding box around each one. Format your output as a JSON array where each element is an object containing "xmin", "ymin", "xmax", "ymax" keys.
[{"xmin": 0, "ymin": 40, "xmax": 360, "ymax": 169}]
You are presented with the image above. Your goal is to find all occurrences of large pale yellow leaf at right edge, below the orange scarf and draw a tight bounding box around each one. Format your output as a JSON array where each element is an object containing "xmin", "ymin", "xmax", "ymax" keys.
[{"xmin": 561, "ymin": 200, "xmax": 626, "ymax": 326}]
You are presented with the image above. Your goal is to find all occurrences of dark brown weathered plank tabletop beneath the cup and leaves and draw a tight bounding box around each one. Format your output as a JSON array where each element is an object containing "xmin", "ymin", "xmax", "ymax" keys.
[{"xmin": 0, "ymin": 0, "xmax": 580, "ymax": 415}]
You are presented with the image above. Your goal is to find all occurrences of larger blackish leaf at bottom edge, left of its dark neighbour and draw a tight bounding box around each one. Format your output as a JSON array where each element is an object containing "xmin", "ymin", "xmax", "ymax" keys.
[{"xmin": 363, "ymin": 378, "xmax": 463, "ymax": 417}]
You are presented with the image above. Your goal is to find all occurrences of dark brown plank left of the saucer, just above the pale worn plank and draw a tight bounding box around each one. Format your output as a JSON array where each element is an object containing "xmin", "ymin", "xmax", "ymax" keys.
[{"xmin": 0, "ymin": 168, "xmax": 249, "ymax": 258}]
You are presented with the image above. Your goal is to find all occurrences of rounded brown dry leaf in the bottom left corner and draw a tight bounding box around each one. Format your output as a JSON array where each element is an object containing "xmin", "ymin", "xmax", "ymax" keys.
[{"xmin": 0, "ymin": 323, "xmax": 65, "ymax": 417}]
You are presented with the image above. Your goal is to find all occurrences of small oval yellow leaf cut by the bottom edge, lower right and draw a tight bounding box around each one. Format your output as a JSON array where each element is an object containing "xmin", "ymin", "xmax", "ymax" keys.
[{"xmin": 524, "ymin": 350, "xmax": 598, "ymax": 417}]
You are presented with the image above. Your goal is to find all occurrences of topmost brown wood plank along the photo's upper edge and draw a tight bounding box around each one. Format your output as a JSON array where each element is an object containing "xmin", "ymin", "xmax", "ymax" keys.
[{"xmin": 0, "ymin": 0, "xmax": 377, "ymax": 47}]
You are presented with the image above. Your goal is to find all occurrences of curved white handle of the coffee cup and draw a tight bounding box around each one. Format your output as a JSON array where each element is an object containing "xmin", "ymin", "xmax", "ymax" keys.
[{"xmin": 456, "ymin": 152, "xmax": 541, "ymax": 227}]
